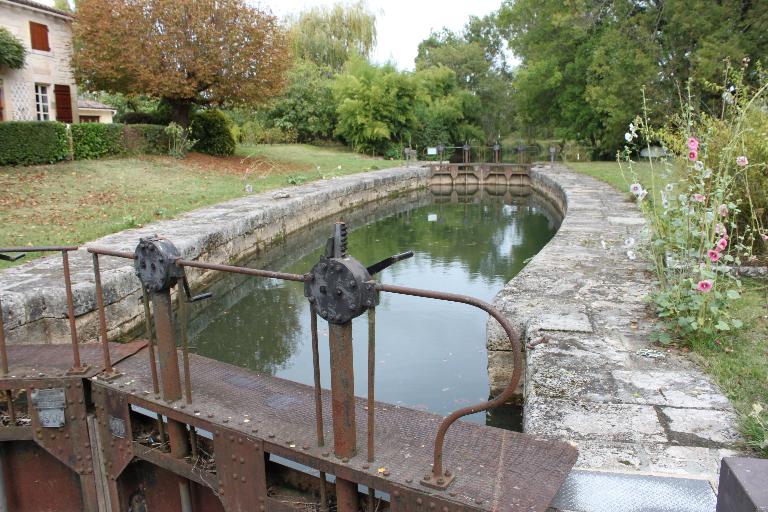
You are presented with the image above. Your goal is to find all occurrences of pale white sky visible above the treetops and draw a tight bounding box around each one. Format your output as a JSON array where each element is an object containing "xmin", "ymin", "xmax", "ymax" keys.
[{"xmin": 38, "ymin": 0, "xmax": 501, "ymax": 70}]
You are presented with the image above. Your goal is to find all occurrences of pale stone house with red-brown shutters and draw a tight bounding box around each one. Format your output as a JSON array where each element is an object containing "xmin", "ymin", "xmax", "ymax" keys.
[{"xmin": 0, "ymin": 0, "xmax": 79, "ymax": 123}]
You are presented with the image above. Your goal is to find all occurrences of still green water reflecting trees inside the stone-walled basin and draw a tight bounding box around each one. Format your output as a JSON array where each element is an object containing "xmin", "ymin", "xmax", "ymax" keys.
[{"xmin": 190, "ymin": 186, "xmax": 559, "ymax": 423}]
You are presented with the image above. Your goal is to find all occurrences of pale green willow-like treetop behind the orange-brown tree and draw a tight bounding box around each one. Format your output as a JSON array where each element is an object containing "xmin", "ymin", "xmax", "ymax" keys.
[{"xmin": 290, "ymin": 1, "xmax": 376, "ymax": 72}]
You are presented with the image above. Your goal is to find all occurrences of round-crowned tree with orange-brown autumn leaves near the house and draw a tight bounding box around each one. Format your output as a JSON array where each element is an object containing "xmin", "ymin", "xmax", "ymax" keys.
[{"xmin": 73, "ymin": 0, "xmax": 289, "ymax": 126}]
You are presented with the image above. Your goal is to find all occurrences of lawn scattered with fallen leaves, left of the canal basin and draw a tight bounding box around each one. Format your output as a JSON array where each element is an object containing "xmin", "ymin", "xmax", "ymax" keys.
[{"xmin": 0, "ymin": 145, "xmax": 401, "ymax": 268}]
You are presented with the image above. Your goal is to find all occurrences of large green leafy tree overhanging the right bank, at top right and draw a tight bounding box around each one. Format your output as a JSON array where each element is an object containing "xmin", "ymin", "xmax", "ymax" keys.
[{"xmin": 498, "ymin": 0, "xmax": 768, "ymax": 157}]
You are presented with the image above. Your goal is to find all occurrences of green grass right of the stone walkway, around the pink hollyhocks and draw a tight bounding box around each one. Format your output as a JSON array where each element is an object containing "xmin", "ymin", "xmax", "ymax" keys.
[{"xmin": 567, "ymin": 158, "xmax": 768, "ymax": 457}]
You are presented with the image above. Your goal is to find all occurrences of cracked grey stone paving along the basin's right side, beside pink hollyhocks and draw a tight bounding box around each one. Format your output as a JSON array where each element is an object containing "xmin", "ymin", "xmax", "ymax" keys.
[{"xmin": 487, "ymin": 165, "xmax": 740, "ymax": 486}]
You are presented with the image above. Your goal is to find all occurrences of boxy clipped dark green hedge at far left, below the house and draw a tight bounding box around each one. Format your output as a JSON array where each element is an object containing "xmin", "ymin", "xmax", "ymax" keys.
[{"xmin": 0, "ymin": 121, "xmax": 69, "ymax": 165}]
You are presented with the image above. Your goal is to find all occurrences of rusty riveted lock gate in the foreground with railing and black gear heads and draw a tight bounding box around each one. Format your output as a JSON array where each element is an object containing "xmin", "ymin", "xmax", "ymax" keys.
[{"xmin": 0, "ymin": 223, "xmax": 577, "ymax": 512}]
